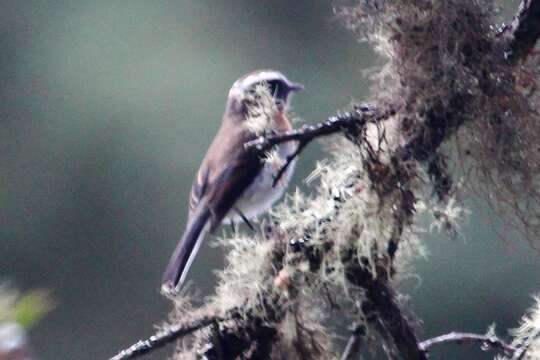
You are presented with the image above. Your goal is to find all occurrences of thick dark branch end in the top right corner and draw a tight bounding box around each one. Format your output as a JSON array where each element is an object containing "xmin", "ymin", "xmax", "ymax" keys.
[{"xmin": 507, "ymin": 0, "xmax": 540, "ymax": 63}]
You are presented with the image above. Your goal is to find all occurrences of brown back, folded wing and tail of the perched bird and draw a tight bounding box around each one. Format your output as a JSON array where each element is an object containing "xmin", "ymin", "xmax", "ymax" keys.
[{"xmin": 163, "ymin": 124, "xmax": 263, "ymax": 289}]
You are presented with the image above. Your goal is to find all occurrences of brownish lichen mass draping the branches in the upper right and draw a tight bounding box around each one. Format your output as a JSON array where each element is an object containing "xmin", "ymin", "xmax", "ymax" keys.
[{"xmin": 335, "ymin": 0, "xmax": 540, "ymax": 245}]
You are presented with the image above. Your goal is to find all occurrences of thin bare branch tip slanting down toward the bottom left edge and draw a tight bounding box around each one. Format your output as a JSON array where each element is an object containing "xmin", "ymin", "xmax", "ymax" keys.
[{"xmin": 110, "ymin": 309, "xmax": 238, "ymax": 360}]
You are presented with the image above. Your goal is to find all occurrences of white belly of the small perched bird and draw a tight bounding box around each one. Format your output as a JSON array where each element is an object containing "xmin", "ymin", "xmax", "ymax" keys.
[{"xmin": 224, "ymin": 143, "xmax": 296, "ymax": 223}]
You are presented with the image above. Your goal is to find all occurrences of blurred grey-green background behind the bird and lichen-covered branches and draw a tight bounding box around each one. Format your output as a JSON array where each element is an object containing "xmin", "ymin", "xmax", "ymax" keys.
[{"xmin": 0, "ymin": 0, "xmax": 540, "ymax": 360}]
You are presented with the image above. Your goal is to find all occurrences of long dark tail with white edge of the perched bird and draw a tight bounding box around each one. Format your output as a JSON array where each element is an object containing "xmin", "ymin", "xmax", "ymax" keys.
[{"xmin": 161, "ymin": 206, "xmax": 210, "ymax": 292}]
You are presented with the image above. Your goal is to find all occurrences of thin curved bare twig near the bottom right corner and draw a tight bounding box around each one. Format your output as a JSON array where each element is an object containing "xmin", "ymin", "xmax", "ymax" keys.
[{"xmin": 419, "ymin": 331, "xmax": 518, "ymax": 355}]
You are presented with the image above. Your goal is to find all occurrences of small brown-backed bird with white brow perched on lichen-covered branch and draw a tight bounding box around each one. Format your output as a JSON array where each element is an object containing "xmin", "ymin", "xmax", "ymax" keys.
[{"xmin": 162, "ymin": 70, "xmax": 303, "ymax": 292}]
